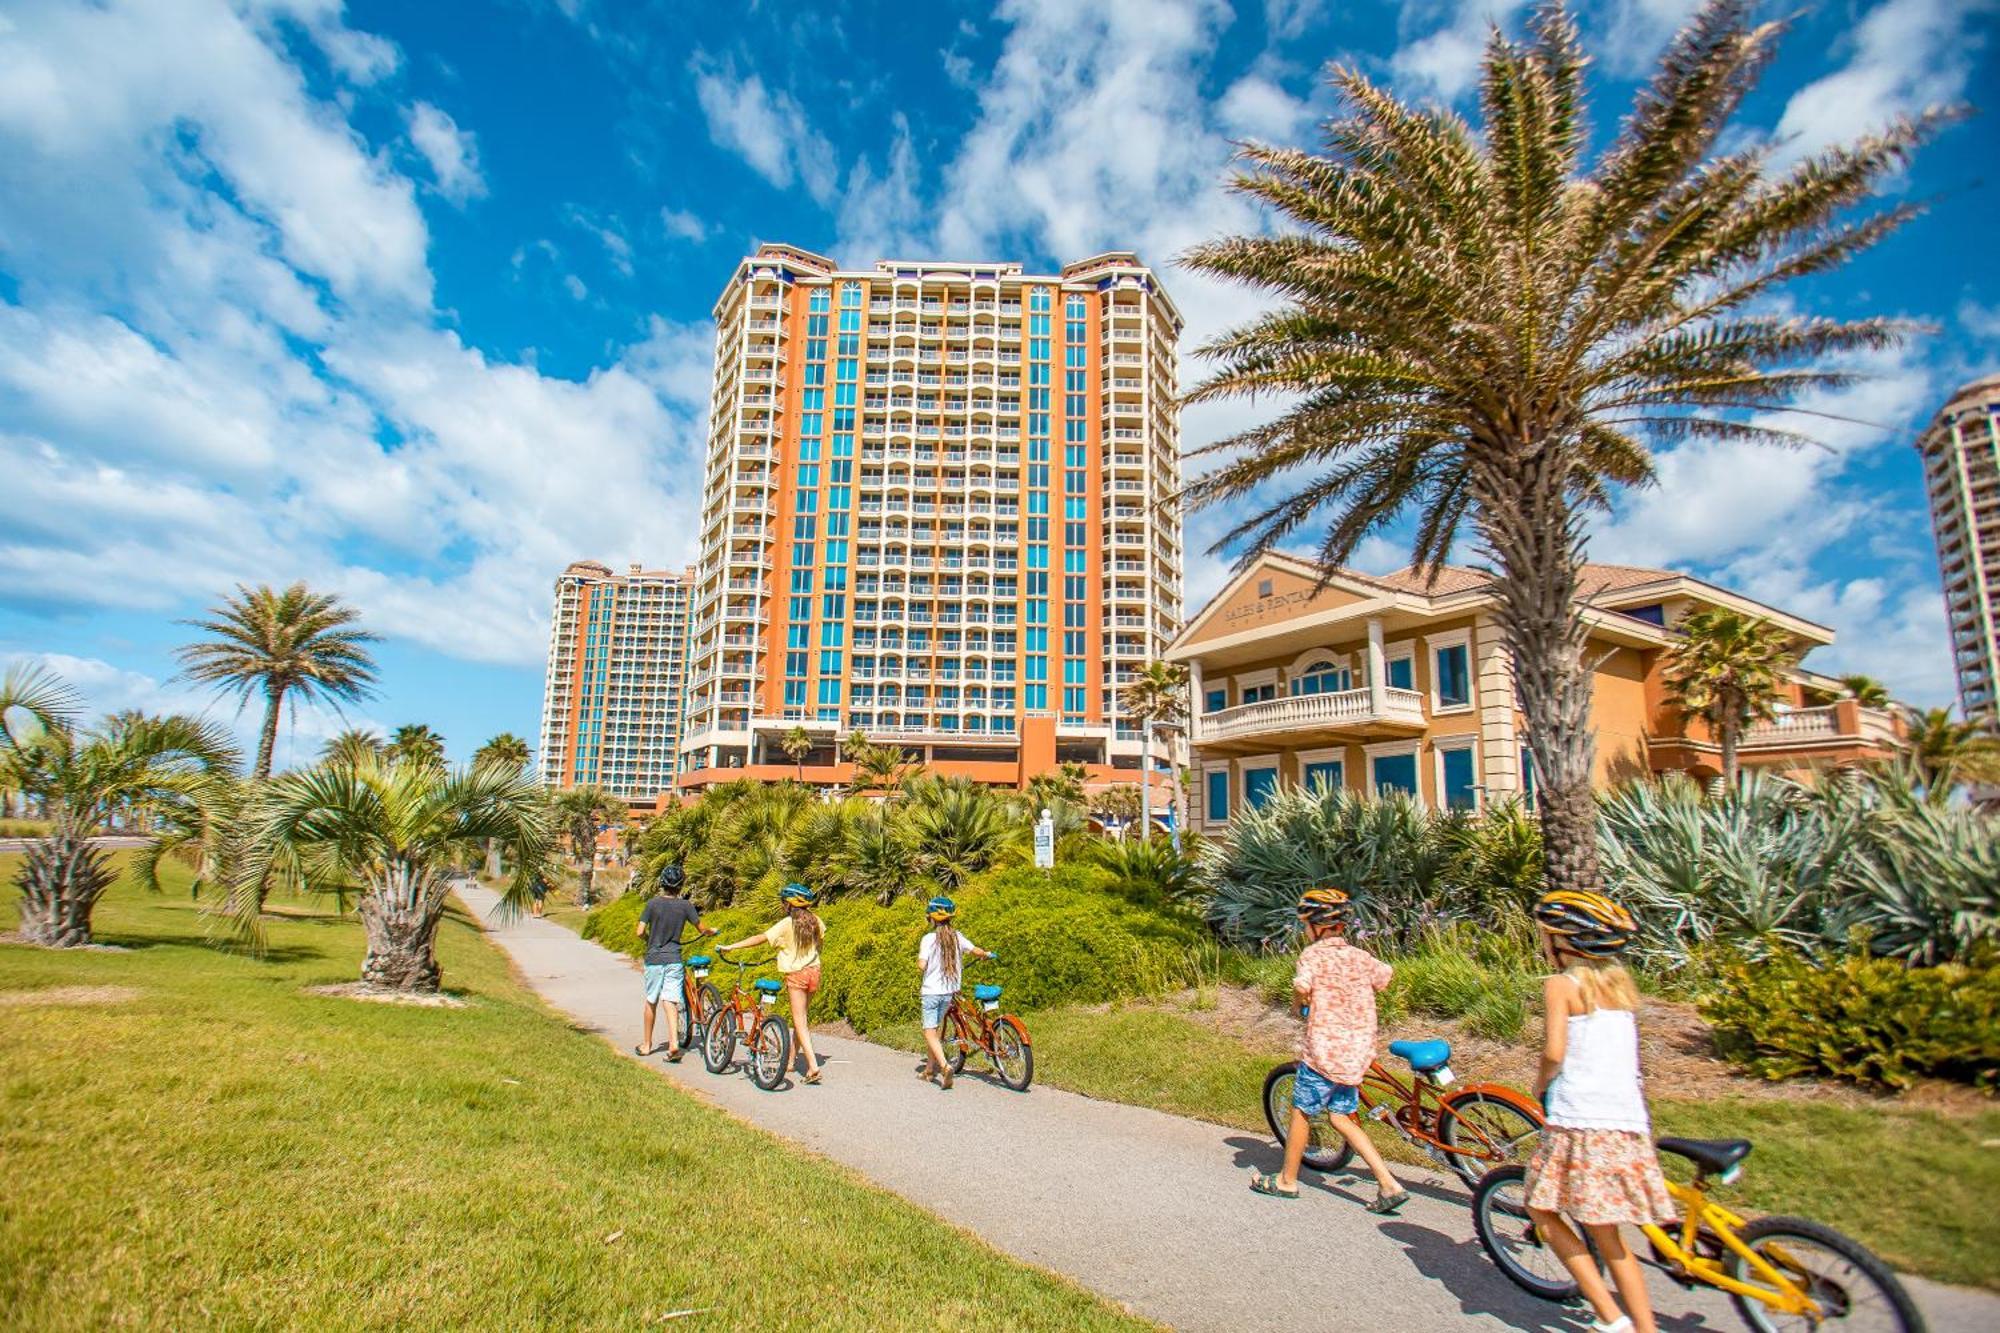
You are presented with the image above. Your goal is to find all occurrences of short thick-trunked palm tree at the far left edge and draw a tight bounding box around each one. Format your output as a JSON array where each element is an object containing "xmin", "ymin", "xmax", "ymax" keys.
[{"xmin": 0, "ymin": 664, "xmax": 240, "ymax": 949}]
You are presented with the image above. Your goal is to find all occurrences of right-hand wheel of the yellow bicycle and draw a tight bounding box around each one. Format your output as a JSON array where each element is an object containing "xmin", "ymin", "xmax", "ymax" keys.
[{"xmin": 1726, "ymin": 1217, "xmax": 1924, "ymax": 1333}]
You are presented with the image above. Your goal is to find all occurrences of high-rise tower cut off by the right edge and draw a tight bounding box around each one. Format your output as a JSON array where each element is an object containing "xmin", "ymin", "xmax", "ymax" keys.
[{"xmin": 1916, "ymin": 374, "xmax": 2000, "ymax": 723}]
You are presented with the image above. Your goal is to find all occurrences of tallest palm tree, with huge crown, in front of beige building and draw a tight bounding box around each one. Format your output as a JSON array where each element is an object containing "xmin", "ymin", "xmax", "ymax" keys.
[{"xmin": 1184, "ymin": 0, "xmax": 1946, "ymax": 889}]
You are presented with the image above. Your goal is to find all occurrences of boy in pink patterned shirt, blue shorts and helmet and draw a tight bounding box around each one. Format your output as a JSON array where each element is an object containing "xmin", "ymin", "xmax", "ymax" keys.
[{"xmin": 1250, "ymin": 889, "xmax": 1410, "ymax": 1213}]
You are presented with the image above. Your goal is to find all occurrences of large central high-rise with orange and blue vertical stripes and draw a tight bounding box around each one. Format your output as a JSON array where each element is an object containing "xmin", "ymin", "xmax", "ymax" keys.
[{"xmin": 680, "ymin": 244, "xmax": 1182, "ymax": 789}]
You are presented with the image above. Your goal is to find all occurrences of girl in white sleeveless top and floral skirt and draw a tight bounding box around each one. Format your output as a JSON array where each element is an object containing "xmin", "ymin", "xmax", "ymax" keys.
[{"xmin": 1526, "ymin": 889, "xmax": 1676, "ymax": 1333}]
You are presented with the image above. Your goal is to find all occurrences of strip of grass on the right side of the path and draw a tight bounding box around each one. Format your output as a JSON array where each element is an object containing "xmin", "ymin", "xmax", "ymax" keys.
[{"xmin": 892, "ymin": 992, "xmax": 2000, "ymax": 1289}]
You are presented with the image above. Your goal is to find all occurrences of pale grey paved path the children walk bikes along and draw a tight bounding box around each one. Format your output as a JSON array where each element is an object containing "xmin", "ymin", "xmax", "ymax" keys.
[{"xmin": 458, "ymin": 883, "xmax": 2000, "ymax": 1333}]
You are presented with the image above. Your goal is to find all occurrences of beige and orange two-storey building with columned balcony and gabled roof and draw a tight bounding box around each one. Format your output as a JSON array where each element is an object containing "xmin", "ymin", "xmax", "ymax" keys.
[{"xmin": 1166, "ymin": 554, "xmax": 1898, "ymax": 831}]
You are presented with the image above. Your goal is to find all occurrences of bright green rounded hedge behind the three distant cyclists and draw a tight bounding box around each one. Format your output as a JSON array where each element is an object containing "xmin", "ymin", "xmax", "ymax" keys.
[{"xmin": 584, "ymin": 865, "xmax": 1200, "ymax": 1033}]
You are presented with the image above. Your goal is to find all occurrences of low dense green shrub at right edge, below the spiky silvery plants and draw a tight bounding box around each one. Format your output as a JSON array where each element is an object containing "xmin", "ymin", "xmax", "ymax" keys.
[{"xmin": 1702, "ymin": 953, "xmax": 2000, "ymax": 1091}]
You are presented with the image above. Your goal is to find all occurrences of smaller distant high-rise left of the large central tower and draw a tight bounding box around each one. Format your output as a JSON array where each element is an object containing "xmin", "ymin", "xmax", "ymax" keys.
[{"xmin": 542, "ymin": 560, "xmax": 692, "ymax": 805}]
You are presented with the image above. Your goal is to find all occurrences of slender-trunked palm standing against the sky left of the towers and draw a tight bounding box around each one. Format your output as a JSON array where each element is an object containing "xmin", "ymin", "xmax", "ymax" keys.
[{"xmin": 178, "ymin": 582, "xmax": 376, "ymax": 781}]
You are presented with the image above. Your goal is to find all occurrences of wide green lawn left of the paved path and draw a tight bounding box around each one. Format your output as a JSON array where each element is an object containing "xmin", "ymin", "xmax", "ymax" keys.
[{"xmin": 0, "ymin": 857, "xmax": 1144, "ymax": 1333}]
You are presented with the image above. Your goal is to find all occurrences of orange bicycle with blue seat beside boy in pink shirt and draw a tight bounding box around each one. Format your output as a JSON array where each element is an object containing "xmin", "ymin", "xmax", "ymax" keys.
[{"xmin": 1264, "ymin": 1041, "xmax": 1542, "ymax": 1189}]
